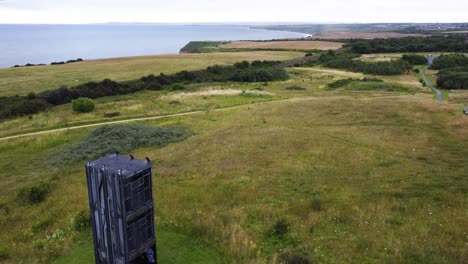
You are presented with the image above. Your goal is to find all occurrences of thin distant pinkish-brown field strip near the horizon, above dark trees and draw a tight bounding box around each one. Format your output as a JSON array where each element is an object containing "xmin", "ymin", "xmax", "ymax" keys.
[{"xmin": 310, "ymin": 32, "xmax": 426, "ymax": 39}]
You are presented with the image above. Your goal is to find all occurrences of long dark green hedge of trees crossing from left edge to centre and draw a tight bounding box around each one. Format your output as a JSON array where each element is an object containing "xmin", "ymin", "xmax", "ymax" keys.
[{"xmin": 0, "ymin": 61, "xmax": 289, "ymax": 119}]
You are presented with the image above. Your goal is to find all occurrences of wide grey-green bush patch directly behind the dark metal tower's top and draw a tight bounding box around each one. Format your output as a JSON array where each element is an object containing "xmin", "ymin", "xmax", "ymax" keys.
[{"xmin": 51, "ymin": 125, "xmax": 193, "ymax": 163}]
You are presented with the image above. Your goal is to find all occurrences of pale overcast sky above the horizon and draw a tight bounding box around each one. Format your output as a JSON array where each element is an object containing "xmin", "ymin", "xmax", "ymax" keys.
[{"xmin": 0, "ymin": 0, "xmax": 468, "ymax": 24}]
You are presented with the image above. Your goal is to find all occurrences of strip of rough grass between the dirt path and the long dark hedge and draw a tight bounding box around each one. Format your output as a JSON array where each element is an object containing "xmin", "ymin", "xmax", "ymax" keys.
[{"xmin": 0, "ymin": 68, "xmax": 424, "ymax": 137}]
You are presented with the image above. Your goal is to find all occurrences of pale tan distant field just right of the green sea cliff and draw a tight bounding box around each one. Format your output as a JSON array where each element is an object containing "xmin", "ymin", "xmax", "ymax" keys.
[{"xmin": 222, "ymin": 40, "xmax": 343, "ymax": 50}]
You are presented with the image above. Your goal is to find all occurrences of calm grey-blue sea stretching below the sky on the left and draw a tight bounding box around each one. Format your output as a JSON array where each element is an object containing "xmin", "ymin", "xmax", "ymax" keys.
[{"xmin": 0, "ymin": 24, "xmax": 304, "ymax": 68}]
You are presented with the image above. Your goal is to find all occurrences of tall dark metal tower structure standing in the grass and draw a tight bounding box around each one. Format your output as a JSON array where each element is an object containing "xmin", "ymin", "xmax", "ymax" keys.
[{"xmin": 86, "ymin": 154, "xmax": 157, "ymax": 264}]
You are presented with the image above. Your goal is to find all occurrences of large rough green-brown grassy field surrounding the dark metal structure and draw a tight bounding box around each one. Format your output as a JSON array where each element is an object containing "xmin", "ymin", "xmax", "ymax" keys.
[{"xmin": 0, "ymin": 50, "xmax": 468, "ymax": 264}]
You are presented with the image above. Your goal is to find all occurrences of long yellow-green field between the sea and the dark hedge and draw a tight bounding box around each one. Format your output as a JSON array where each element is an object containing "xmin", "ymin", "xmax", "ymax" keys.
[{"xmin": 0, "ymin": 51, "xmax": 304, "ymax": 96}]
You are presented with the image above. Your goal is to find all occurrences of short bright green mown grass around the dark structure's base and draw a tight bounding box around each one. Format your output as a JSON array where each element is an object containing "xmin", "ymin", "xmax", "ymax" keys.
[{"xmin": 53, "ymin": 230, "xmax": 221, "ymax": 264}]
